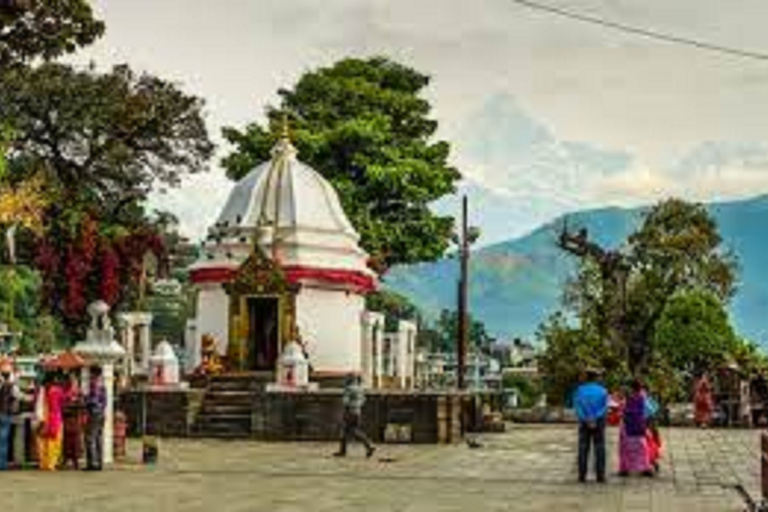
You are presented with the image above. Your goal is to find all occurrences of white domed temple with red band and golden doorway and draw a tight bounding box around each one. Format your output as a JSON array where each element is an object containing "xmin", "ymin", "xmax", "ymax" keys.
[{"xmin": 186, "ymin": 128, "xmax": 415, "ymax": 387}]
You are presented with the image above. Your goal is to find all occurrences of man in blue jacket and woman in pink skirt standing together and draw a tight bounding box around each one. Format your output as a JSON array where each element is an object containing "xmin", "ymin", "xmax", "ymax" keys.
[{"xmin": 573, "ymin": 370, "xmax": 662, "ymax": 482}]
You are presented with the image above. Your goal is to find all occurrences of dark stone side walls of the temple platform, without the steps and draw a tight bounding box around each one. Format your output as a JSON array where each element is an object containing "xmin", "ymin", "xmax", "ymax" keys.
[{"xmin": 118, "ymin": 389, "xmax": 471, "ymax": 443}]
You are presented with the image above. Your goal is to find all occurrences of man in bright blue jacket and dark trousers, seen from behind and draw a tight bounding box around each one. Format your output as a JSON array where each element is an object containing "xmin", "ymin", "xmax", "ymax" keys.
[{"xmin": 573, "ymin": 369, "xmax": 608, "ymax": 483}]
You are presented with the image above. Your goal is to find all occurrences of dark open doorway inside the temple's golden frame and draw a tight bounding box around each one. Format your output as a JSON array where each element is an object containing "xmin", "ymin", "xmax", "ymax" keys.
[{"xmin": 246, "ymin": 297, "xmax": 279, "ymax": 371}]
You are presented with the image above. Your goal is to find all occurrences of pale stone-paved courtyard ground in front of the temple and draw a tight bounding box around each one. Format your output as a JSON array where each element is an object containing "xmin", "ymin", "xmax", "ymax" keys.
[{"xmin": 0, "ymin": 426, "xmax": 759, "ymax": 512}]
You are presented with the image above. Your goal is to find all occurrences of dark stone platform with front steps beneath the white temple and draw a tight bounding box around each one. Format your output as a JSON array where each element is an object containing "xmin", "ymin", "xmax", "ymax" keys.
[{"xmin": 118, "ymin": 376, "xmax": 484, "ymax": 443}]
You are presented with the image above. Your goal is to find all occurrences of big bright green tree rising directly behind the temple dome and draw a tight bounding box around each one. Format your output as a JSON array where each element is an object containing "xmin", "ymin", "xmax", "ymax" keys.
[{"xmin": 223, "ymin": 58, "xmax": 459, "ymax": 270}]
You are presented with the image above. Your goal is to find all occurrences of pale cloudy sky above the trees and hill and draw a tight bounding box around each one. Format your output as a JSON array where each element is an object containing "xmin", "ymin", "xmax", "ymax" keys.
[{"xmin": 70, "ymin": 0, "xmax": 768, "ymax": 244}]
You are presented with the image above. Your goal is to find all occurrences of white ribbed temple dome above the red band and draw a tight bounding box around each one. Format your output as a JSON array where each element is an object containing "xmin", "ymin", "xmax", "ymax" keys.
[{"xmin": 190, "ymin": 137, "xmax": 375, "ymax": 287}]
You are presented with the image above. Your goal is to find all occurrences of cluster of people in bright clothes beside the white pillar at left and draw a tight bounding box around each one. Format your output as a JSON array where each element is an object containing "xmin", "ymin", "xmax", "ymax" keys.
[{"xmin": 0, "ymin": 362, "xmax": 106, "ymax": 471}]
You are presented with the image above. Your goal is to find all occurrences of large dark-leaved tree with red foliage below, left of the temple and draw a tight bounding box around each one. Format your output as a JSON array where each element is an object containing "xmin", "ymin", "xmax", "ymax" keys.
[{"xmin": 0, "ymin": 63, "xmax": 213, "ymax": 336}]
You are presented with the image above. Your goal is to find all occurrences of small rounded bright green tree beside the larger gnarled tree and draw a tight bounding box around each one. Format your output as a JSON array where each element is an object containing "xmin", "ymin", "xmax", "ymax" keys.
[{"xmin": 653, "ymin": 291, "xmax": 740, "ymax": 374}]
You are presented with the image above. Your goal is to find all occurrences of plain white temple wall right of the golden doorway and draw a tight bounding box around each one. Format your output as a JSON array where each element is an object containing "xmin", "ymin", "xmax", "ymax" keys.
[{"xmin": 296, "ymin": 286, "xmax": 365, "ymax": 374}]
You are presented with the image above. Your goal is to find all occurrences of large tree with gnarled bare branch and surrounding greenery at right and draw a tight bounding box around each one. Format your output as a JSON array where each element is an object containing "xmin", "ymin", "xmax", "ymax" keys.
[{"xmin": 540, "ymin": 199, "xmax": 741, "ymax": 397}]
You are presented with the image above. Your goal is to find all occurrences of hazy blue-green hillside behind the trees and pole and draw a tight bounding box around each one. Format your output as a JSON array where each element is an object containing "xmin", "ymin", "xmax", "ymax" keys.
[{"xmin": 385, "ymin": 196, "xmax": 768, "ymax": 348}]
